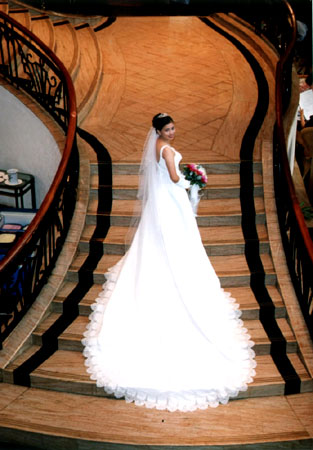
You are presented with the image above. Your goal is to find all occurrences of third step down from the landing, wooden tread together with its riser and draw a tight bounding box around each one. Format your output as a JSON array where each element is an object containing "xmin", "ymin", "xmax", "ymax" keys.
[{"xmin": 86, "ymin": 197, "xmax": 266, "ymax": 227}]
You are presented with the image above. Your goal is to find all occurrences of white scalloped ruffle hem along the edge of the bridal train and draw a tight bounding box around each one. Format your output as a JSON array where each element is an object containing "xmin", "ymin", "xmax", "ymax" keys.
[{"xmin": 82, "ymin": 258, "xmax": 256, "ymax": 412}]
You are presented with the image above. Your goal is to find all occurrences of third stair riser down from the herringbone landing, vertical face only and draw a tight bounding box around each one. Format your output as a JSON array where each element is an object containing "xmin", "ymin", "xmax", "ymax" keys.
[{"xmin": 86, "ymin": 214, "xmax": 266, "ymax": 227}]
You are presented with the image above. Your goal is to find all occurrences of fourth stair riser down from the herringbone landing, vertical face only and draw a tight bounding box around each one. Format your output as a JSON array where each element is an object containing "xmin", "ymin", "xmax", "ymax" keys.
[{"xmin": 79, "ymin": 242, "xmax": 269, "ymax": 256}]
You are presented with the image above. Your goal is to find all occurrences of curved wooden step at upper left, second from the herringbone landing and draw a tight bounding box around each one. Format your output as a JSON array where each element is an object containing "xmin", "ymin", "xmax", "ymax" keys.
[{"xmin": 53, "ymin": 20, "xmax": 80, "ymax": 80}]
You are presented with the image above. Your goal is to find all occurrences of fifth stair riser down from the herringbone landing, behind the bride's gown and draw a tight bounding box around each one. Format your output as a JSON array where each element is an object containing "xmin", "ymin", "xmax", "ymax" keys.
[{"xmin": 66, "ymin": 270, "xmax": 277, "ymax": 291}]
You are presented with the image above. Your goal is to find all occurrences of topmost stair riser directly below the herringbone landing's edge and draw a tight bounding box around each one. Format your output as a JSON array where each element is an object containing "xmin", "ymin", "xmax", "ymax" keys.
[{"xmin": 90, "ymin": 160, "xmax": 262, "ymax": 175}]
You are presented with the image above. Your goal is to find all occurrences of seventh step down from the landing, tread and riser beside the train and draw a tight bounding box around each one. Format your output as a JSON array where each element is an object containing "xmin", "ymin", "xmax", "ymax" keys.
[{"xmin": 32, "ymin": 313, "xmax": 298, "ymax": 355}]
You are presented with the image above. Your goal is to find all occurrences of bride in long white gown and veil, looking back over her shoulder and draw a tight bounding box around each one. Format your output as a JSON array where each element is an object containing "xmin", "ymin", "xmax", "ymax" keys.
[{"xmin": 82, "ymin": 114, "xmax": 256, "ymax": 411}]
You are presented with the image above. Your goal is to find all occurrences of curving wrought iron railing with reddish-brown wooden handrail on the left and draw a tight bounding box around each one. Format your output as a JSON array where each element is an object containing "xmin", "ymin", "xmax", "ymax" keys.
[{"xmin": 0, "ymin": 12, "xmax": 78, "ymax": 348}]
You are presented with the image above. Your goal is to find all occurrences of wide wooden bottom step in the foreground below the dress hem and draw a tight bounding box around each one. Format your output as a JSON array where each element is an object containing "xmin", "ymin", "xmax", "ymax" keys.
[{"xmin": 0, "ymin": 383, "xmax": 313, "ymax": 450}]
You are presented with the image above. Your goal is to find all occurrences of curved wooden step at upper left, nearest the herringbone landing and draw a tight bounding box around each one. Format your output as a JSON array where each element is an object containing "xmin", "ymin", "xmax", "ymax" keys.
[{"xmin": 74, "ymin": 24, "xmax": 102, "ymax": 123}]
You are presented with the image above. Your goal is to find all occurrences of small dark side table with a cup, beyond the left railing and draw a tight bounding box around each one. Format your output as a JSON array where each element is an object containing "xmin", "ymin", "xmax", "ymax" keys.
[{"xmin": 0, "ymin": 169, "xmax": 36, "ymax": 209}]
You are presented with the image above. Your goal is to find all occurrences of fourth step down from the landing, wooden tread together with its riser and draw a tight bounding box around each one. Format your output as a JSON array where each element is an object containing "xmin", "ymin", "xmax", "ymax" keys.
[{"xmin": 79, "ymin": 224, "xmax": 269, "ymax": 256}]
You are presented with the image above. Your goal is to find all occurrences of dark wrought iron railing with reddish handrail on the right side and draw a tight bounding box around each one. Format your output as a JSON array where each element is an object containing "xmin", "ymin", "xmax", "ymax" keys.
[{"xmin": 273, "ymin": 2, "xmax": 313, "ymax": 339}]
